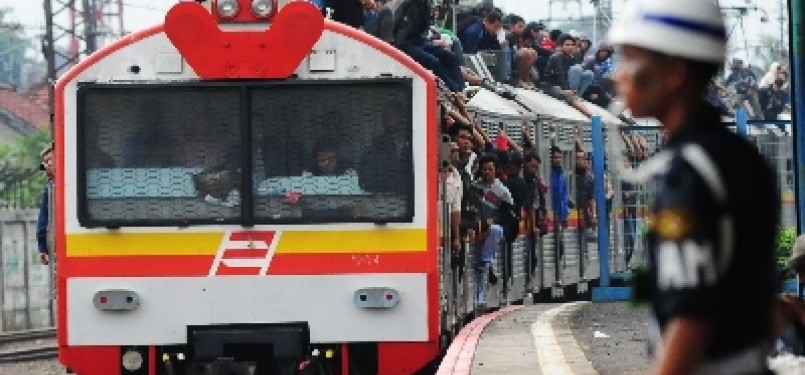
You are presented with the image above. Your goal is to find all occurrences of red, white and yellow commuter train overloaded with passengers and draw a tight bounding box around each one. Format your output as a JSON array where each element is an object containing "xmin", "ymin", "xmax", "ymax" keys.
[{"xmin": 47, "ymin": 0, "xmax": 668, "ymax": 375}]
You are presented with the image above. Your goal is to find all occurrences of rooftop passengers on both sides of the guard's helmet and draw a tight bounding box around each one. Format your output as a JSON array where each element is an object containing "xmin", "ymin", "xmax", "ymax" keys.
[{"xmin": 313, "ymin": 0, "xmax": 790, "ymax": 125}]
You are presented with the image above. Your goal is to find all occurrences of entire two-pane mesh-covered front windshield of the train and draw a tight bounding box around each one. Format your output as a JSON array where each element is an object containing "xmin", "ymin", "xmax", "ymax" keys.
[{"xmin": 77, "ymin": 79, "xmax": 414, "ymax": 227}]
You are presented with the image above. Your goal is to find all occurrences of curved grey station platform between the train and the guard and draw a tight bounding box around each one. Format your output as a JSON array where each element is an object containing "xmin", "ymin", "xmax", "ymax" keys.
[{"xmin": 436, "ymin": 302, "xmax": 805, "ymax": 375}]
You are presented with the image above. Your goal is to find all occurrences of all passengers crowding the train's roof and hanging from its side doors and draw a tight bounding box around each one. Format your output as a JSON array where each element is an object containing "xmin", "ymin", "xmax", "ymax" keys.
[{"xmin": 316, "ymin": 0, "xmax": 789, "ymax": 294}]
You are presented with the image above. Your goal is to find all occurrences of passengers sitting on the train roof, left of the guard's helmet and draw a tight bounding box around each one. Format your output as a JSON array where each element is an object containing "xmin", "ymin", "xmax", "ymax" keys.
[{"xmin": 319, "ymin": 0, "xmax": 614, "ymax": 116}]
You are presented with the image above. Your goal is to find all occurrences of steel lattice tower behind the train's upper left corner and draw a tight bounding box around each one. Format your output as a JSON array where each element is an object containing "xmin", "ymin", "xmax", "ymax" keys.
[{"xmin": 42, "ymin": 0, "xmax": 125, "ymax": 134}]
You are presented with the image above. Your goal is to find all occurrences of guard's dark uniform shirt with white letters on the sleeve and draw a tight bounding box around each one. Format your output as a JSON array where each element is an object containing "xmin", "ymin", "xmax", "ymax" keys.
[{"xmin": 648, "ymin": 103, "xmax": 780, "ymax": 359}]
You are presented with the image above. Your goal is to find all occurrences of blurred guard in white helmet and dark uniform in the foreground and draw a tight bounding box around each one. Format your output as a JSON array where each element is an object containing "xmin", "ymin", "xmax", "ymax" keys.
[{"xmin": 609, "ymin": 0, "xmax": 779, "ymax": 375}]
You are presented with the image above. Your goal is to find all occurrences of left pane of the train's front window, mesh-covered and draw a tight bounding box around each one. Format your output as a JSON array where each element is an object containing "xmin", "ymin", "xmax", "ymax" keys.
[{"xmin": 79, "ymin": 85, "xmax": 243, "ymax": 226}]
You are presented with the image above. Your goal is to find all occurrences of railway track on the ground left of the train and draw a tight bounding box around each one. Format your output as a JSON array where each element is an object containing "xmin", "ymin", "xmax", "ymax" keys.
[{"xmin": 0, "ymin": 328, "xmax": 58, "ymax": 363}]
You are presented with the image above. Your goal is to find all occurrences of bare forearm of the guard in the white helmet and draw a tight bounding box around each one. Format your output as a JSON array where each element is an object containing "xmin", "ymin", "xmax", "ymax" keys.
[{"xmin": 651, "ymin": 316, "xmax": 713, "ymax": 375}]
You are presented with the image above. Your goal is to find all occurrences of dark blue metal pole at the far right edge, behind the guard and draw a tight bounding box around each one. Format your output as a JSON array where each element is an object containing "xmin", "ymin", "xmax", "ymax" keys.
[{"xmin": 788, "ymin": 0, "xmax": 805, "ymax": 233}]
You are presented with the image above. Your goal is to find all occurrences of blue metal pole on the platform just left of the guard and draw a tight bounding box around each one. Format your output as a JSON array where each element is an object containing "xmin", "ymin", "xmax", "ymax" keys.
[{"xmin": 592, "ymin": 116, "xmax": 609, "ymax": 287}]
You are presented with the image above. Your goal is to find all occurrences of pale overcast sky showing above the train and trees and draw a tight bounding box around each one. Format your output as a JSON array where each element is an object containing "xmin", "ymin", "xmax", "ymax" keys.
[{"xmin": 0, "ymin": 0, "xmax": 788, "ymax": 65}]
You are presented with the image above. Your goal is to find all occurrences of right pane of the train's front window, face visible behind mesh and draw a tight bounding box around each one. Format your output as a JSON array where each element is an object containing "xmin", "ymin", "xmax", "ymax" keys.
[{"xmin": 251, "ymin": 81, "xmax": 414, "ymax": 222}]
